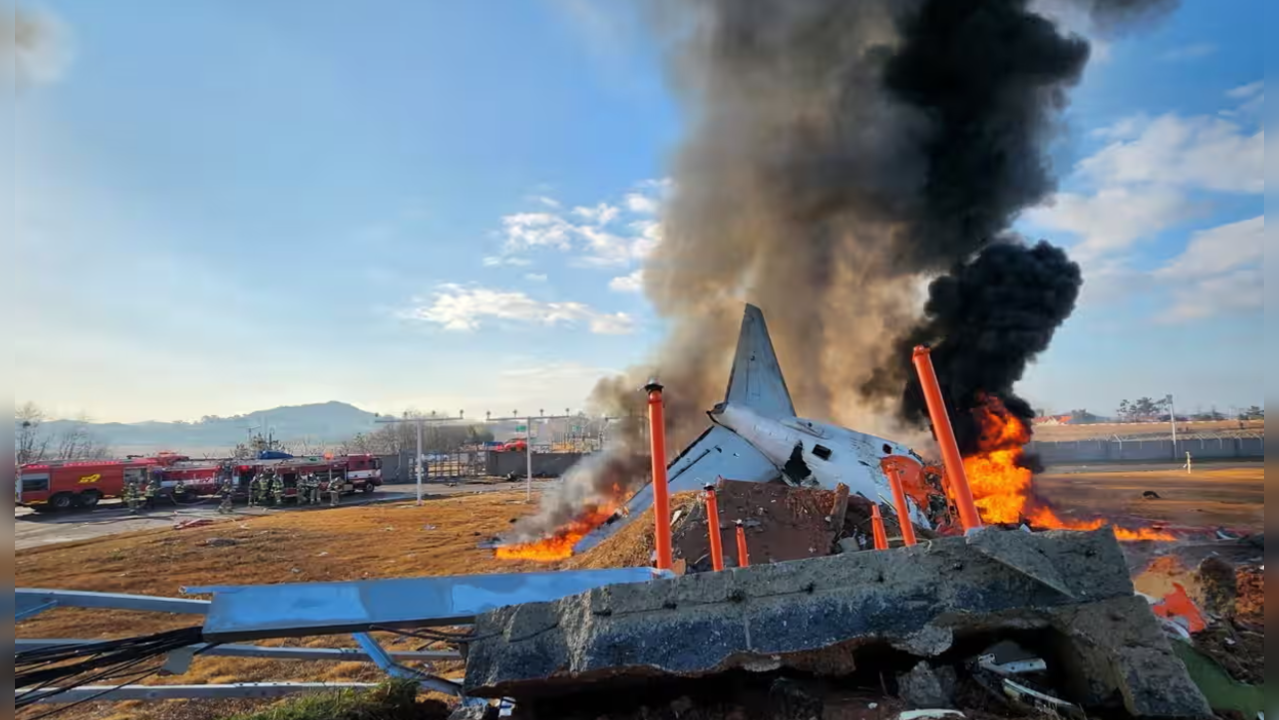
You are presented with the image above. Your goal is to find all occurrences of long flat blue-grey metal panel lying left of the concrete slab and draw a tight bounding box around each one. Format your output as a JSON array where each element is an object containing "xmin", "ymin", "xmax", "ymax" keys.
[{"xmin": 196, "ymin": 568, "xmax": 656, "ymax": 642}]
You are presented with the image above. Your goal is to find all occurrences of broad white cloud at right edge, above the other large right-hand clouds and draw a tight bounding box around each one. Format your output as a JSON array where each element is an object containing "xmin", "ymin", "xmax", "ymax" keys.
[{"xmin": 1079, "ymin": 115, "xmax": 1265, "ymax": 193}]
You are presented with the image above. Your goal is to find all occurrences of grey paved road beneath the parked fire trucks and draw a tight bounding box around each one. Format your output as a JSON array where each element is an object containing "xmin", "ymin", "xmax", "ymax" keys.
[{"xmin": 14, "ymin": 481, "xmax": 555, "ymax": 550}]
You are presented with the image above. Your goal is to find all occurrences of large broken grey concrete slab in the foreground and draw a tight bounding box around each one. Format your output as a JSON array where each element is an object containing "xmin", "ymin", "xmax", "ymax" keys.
[{"xmin": 464, "ymin": 528, "xmax": 1211, "ymax": 717}]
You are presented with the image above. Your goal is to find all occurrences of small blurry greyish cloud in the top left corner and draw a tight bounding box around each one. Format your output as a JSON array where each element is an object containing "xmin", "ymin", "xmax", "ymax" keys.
[{"xmin": 0, "ymin": 6, "xmax": 75, "ymax": 84}]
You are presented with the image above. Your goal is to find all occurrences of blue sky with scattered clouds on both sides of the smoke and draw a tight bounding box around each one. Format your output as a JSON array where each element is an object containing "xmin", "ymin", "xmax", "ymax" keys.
[{"xmin": 7, "ymin": 0, "xmax": 1264, "ymax": 421}]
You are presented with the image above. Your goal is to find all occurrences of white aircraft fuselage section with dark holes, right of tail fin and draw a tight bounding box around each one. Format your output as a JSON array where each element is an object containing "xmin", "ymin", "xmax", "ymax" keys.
[{"xmin": 711, "ymin": 404, "xmax": 930, "ymax": 527}]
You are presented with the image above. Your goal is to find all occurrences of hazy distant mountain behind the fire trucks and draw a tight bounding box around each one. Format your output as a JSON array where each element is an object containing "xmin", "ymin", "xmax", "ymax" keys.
[{"xmin": 27, "ymin": 402, "xmax": 377, "ymax": 453}]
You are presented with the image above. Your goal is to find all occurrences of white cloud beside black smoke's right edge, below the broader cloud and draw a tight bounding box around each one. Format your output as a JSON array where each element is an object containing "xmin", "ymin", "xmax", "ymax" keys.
[{"xmin": 1026, "ymin": 187, "xmax": 1196, "ymax": 260}]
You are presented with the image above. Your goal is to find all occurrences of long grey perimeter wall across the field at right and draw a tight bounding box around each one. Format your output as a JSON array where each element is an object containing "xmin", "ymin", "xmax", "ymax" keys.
[{"xmin": 1027, "ymin": 435, "xmax": 1266, "ymax": 466}]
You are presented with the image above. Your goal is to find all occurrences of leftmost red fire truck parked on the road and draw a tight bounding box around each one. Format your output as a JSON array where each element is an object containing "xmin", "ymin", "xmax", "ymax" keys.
[{"xmin": 14, "ymin": 453, "xmax": 188, "ymax": 510}]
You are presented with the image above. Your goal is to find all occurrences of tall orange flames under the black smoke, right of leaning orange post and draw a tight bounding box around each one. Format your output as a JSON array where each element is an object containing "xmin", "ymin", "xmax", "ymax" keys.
[{"xmin": 963, "ymin": 396, "xmax": 1177, "ymax": 541}]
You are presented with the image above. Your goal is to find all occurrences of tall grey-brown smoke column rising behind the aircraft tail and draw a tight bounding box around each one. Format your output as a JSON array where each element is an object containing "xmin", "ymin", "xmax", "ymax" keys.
[{"xmin": 501, "ymin": 0, "xmax": 1172, "ymax": 544}]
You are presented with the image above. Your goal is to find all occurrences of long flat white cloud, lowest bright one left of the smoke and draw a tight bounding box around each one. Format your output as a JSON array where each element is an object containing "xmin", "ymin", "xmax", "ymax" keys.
[{"xmin": 400, "ymin": 284, "xmax": 634, "ymax": 335}]
